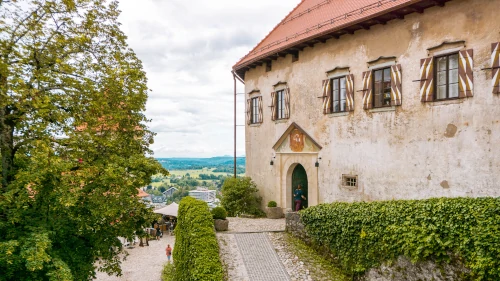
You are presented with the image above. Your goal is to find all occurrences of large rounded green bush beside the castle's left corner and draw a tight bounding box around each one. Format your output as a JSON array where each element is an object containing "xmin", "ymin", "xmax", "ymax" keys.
[{"xmin": 221, "ymin": 177, "xmax": 265, "ymax": 217}]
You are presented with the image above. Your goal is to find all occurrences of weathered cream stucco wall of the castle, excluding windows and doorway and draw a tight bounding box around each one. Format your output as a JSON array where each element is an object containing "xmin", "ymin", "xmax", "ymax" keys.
[{"xmin": 245, "ymin": 0, "xmax": 500, "ymax": 207}]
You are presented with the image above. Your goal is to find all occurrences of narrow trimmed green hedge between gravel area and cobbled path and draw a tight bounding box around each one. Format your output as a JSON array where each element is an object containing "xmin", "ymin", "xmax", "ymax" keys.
[{"xmin": 173, "ymin": 196, "xmax": 223, "ymax": 281}]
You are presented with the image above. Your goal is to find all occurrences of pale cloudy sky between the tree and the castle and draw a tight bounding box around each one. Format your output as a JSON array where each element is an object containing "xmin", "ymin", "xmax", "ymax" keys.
[{"xmin": 115, "ymin": 0, "xmax": 300, "ymax": 157}]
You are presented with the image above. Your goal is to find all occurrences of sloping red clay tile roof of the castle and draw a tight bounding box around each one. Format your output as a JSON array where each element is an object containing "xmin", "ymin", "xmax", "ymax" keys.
[{"xmin": 233, "ymin": 0, "xmax": 421, "ymax": 70}]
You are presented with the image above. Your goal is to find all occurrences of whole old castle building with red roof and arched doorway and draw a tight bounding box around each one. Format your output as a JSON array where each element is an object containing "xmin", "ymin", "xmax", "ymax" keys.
[{"xmin": 233, "ymin": 0, "xmax": 500, "ymax": 208}]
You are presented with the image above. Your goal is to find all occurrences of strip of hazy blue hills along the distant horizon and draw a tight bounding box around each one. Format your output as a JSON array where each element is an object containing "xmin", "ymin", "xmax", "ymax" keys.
[{"xmin": 157, "ymin": 156, "xmax": 246, "ymax": 174}]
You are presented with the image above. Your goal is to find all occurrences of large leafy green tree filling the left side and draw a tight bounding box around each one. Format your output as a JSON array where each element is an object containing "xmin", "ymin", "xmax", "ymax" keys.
[{"xmin": 0, "ymin": 0, "xmax": 168, "ymax": 280}]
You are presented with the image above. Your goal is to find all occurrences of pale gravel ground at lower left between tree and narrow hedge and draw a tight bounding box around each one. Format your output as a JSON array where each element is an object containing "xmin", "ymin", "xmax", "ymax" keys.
[{"xmin": 95, "ymin": 235, "xmax": 175, "ymax": 281}]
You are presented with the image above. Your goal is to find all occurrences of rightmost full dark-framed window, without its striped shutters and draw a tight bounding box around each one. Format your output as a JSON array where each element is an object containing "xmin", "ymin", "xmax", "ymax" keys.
[{"xmin": 434, "ymin": 54, "xmax": 458, "ymax": 100}]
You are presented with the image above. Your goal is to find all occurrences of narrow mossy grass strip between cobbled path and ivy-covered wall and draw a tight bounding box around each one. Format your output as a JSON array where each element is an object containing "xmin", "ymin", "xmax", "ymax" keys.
[{"xmin": 284, "ymin": 233, "xmax": 351, "ymax": 281}]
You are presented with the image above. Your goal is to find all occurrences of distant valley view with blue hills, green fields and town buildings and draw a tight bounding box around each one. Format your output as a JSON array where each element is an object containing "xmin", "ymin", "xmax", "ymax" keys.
[{"xmin": 143, "ymin": 156, "xmax": 246, "ymax": 207}]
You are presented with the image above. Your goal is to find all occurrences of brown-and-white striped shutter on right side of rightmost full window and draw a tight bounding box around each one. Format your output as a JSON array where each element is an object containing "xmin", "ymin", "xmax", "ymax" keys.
[{"xmin": 458, "ymin": 49, "xmax": 474, "ymax": 99}]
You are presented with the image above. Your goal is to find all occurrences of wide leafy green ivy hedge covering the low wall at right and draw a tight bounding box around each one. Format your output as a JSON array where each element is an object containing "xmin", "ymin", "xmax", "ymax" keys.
[{"xmin": 300, "ymin": 198, "xmax": 500, "ymax": 280}]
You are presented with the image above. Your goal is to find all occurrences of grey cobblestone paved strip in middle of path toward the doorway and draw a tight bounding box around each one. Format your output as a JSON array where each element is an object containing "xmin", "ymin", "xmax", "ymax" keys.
[{"xmin": 234, "ymin": 233, "xmax": 290, "ymax": 281}]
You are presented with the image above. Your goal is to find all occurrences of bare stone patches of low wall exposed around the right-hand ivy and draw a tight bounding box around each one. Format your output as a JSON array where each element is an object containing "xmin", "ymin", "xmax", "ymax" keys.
[{"xmin": 285, "ymin": 212, "xmax": 469, "ymax": 281}]
